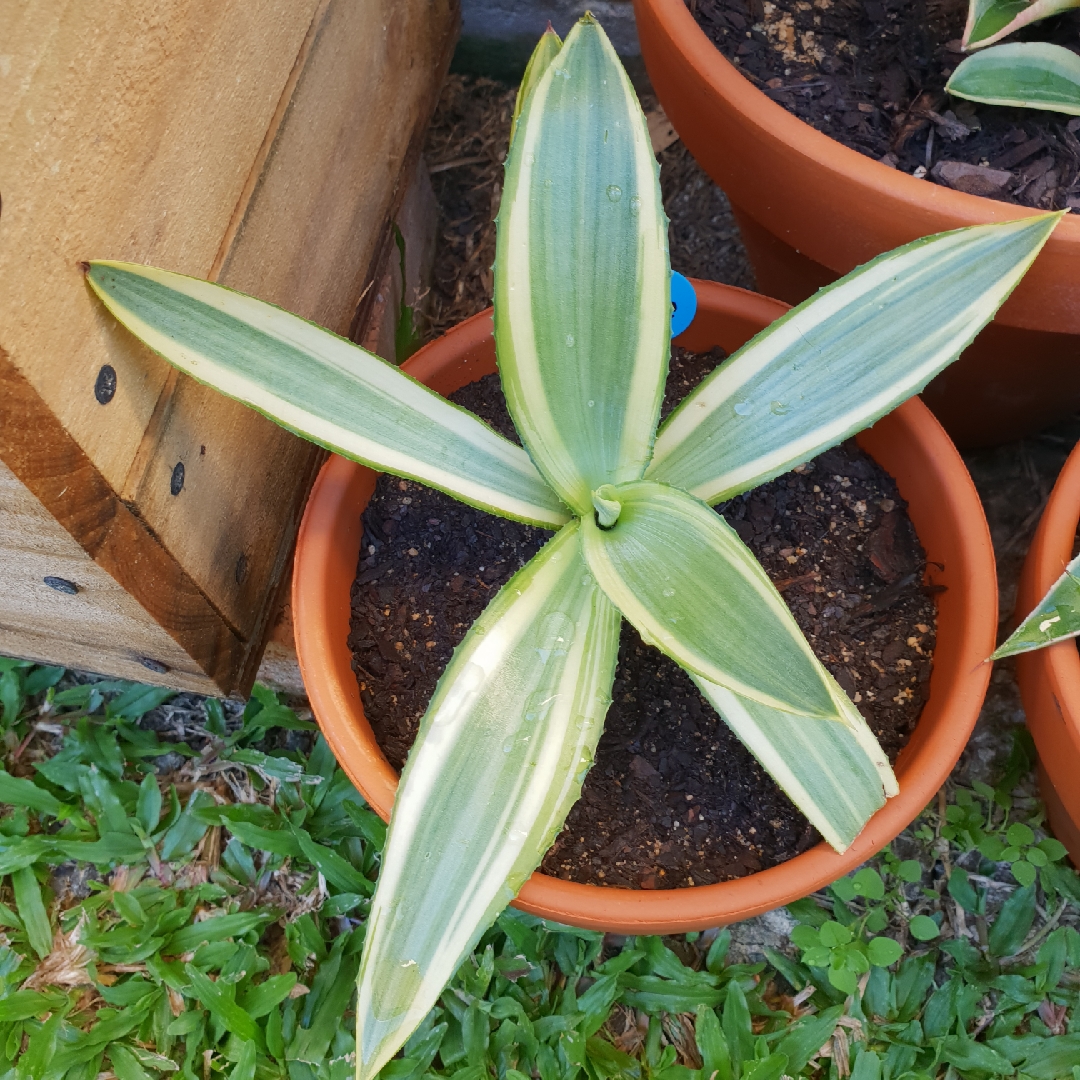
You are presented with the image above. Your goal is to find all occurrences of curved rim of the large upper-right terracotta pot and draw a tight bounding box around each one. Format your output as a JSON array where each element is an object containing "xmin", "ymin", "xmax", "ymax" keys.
[{"xmin": 634, "ymin": 0, "xmax": 1080, "ymax": 236}]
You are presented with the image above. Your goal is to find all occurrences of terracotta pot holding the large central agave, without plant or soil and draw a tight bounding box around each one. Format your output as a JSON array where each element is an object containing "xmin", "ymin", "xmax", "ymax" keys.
[{"xmin": 293, "ymin": 282, "xmax": 997, "ymax": 933}]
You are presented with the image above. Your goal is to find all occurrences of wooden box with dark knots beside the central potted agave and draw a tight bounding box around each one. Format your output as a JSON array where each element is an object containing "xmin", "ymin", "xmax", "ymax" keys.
[{"xmin": 0, "ymin": 0, "xmax": 459, "ymax": 693}]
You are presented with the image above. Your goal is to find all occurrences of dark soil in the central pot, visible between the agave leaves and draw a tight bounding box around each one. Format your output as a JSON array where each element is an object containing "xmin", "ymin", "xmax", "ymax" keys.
[{"xmin": 349, "ymin": 349, "xmax": 935, "ymax": 889}]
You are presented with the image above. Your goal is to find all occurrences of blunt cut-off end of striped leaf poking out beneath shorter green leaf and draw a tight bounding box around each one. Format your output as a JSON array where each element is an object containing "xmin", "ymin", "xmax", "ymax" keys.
[{"xmin": 690, "ymin": 672, "xmax": 900, "ymax": 852}]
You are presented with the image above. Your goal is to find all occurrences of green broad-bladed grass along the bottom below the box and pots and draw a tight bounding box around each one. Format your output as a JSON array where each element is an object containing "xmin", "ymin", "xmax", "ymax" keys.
[{"xmin": 0, "ymin": 659, "xmax": 1080, "ymax": 1080}]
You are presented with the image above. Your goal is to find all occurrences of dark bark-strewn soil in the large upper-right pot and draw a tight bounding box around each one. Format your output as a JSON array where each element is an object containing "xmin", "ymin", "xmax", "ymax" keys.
[{"xmin": 688, "ymin": 0, "xmax": 1080, "ymax": 210}]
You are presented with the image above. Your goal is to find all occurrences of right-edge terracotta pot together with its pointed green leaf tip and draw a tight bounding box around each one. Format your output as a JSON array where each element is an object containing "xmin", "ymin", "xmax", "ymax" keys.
[{"xmin": 990, "ymin": 447, "xmax": 1080, "ymax": 866}]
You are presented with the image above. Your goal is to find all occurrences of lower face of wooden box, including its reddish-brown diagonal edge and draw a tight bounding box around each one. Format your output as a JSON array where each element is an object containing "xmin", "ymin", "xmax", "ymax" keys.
[{"xmin": 0, "ymin": 350, "xmax": 243, "ymax": 692}]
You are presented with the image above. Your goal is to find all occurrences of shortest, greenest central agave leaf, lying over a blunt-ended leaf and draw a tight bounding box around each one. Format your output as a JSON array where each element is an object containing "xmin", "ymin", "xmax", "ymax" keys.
[{"xmin": 582, "ymin": 481, "xmax": 836, "ymax": 716}]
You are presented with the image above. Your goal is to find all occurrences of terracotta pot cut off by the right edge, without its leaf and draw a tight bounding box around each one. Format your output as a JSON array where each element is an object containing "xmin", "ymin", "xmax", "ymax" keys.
[{"xmin": 1016, "ymin": 446, "xmax": 1080, "ymax": 866}]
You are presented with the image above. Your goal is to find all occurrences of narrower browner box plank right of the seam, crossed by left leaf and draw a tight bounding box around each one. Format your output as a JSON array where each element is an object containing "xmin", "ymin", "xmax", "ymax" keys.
[{"xmin": 113, "ymin": 0, "xmax": 457, "ymax": 637}]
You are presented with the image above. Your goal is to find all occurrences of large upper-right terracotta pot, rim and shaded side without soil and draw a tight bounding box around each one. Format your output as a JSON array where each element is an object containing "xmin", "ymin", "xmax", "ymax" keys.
[{"xmin": 634, "ymin": 0, "xmax": 1080, "ymax": 446}]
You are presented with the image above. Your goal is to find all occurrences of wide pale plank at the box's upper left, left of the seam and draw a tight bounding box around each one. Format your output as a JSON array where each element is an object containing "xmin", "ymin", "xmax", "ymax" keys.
[{"xmin": 0, "ymin": 0, "xmax": 319, "ymax": 490}]
